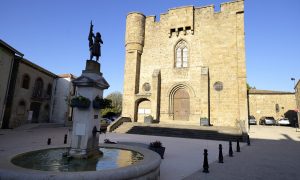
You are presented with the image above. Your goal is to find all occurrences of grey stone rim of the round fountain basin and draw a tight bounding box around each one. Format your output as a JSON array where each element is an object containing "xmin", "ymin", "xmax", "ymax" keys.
[{"xmin": 0, "ymin": 144, "xmax": 161, "ymax": 180}]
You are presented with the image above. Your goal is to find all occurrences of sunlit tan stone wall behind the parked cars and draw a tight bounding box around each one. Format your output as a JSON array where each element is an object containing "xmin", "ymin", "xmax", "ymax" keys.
[{"xmin": 249, "ymin": 91, "xmax": 296, "ymax": 121}]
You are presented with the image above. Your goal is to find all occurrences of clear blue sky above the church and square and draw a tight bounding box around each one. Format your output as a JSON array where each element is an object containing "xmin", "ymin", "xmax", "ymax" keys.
[{"xmin": 0, "ymin": 0, "xmax": 300, "ymax": 95}]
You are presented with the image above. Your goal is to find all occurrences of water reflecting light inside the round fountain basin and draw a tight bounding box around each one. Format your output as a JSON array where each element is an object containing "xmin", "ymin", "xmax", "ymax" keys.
[{"xmin": 11, "ymin": 148, "xmax": 144, "ymax": 172}]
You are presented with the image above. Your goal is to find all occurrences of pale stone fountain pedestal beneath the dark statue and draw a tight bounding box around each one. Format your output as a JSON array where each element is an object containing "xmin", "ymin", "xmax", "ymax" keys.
[{"xmin": 69, "ymin": 60, "xmax": 109, "ymax": 158}]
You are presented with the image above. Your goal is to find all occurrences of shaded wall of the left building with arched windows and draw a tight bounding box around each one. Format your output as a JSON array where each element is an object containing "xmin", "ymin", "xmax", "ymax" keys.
[{"xmin": 9, "ymin": 59, "xmax": 56, "ymax": 128}]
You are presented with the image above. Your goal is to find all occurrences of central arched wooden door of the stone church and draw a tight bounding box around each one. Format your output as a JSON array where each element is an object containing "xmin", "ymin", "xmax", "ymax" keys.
[{"xmin": 173, "ymin": 89, "xmax": 190, "ymax": 120}]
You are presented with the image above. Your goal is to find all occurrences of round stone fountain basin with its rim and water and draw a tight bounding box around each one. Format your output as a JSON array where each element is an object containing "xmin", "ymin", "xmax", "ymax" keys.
[{"xmin": 0, "ymin": 144, "xmax": 161, "ymax": 179}]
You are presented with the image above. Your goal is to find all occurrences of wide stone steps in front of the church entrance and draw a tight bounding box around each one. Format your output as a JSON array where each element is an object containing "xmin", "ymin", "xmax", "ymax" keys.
[{"xmin": 113, "ymin": 122, "xmax": 247, "ymax": 142}]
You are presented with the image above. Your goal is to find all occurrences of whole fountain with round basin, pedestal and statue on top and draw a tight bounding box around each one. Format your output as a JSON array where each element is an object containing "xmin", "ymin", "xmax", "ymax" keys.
[{"xmin": 0, "ymin": 23, "xmax": 161, "ymax": 179}]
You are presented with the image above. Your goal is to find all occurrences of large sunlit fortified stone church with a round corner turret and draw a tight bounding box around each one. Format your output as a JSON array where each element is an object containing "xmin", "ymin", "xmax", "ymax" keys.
[{"xmin": 122, "ymin": 1, "xmax": 248, "ymax": 127}]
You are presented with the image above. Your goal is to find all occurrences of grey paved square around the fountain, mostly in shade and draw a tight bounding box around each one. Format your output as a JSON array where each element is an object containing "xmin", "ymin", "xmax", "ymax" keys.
[{"xmin": 0, "ymin": 125, "xmax": 300, "ymax": 180}]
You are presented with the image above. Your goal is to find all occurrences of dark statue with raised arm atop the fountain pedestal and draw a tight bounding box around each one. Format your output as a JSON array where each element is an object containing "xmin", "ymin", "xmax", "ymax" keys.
[{"xmin": 88, "ymin": 21, "xmax": 103, "ymax": 61}]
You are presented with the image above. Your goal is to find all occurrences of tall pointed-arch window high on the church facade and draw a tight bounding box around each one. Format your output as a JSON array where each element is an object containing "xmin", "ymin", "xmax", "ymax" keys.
[{"xmin": 175, "ymin": 40, "xmax": 189, "ymax": 68}]
